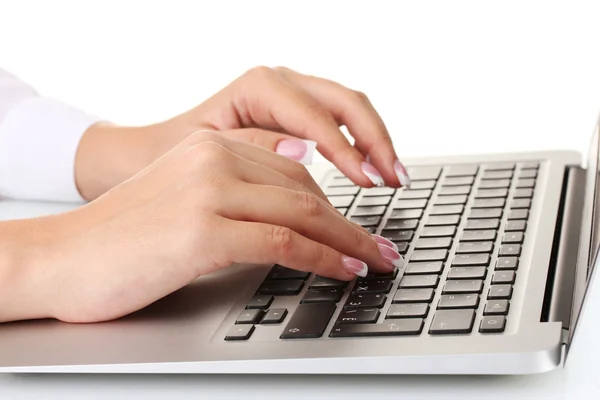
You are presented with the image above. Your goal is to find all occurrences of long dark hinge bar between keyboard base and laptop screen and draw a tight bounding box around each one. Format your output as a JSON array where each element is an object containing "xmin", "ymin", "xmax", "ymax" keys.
[{"xmin": 542, "ymin": 166, "xmax": 586, "ymax": 340}]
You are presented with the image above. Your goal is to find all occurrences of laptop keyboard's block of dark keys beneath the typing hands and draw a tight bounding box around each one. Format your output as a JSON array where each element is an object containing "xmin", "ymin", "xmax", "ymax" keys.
[{"xmin": 225, "ymin": 162, "xmax": 539, "ymax": 340}]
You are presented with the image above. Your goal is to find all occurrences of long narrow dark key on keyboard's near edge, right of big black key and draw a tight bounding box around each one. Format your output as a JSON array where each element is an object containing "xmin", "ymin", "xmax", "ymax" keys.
[{"xmin": 329, "ymin": 318, "xmax": 423, "ymax": 337}]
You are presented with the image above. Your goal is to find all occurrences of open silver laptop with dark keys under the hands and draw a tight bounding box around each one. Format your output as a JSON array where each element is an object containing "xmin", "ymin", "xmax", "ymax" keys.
[{"xmin": 0, "ymin": 115, "xmax": 600, "ymax": 375}]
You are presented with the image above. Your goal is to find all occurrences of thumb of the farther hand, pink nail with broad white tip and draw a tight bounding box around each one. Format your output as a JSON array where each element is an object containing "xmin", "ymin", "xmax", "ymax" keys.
[{"xmin": 220, "ymin": 128, "xmax": 316, "ymax": 165}]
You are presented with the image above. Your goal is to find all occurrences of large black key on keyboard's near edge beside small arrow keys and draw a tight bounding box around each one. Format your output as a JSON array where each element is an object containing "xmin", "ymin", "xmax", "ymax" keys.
[{"xmin": 279, "ymin": 303, "xmax": 335, "ymax": 339}]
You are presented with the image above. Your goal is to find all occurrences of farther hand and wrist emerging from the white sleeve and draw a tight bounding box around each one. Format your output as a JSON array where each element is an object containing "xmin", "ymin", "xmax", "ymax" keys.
[{"xmin": 76, "ymin": 67, "xmax": 410, "ymax": 200}]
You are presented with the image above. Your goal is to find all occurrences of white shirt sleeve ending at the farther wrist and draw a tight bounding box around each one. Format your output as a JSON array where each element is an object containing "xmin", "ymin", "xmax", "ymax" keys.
[{"xmin": 0, "ymin": 69, "xmax": 100, "ymax": 202}]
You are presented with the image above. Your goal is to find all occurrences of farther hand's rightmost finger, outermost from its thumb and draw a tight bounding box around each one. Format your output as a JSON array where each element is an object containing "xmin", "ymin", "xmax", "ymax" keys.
[{"xmin": 276, "ymin": 67, "xmax": 410, "ymax": 187}]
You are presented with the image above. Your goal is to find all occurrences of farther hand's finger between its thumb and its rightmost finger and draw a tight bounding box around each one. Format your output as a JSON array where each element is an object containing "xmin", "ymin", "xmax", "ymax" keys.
[{"xmin": 224, "ymin": 68, "xmax": 383, "ymax": 187}]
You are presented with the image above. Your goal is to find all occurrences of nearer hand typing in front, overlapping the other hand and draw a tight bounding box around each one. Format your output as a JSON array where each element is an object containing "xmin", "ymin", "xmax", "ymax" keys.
[{"xmin": 16, "ymin": 131, "xmax": 402, "ymax": 322}]
